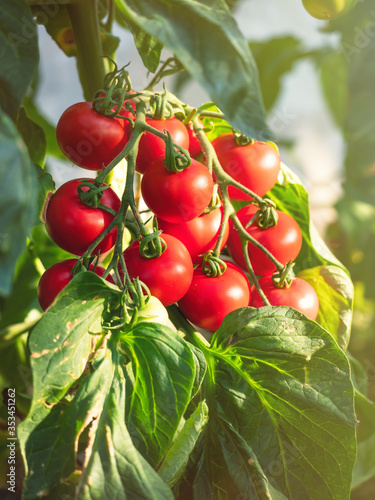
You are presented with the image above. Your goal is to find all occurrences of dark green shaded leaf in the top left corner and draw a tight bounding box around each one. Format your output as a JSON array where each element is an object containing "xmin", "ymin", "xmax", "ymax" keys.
[{"xmin": 0, "ymin": 0, "xmax": 39, "ymax": 120}]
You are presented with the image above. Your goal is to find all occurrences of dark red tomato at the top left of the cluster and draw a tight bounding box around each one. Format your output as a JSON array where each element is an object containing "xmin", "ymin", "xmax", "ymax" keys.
[{"xmin": 56, "ymin": 102, "xmax": 127, "ymax": 170}]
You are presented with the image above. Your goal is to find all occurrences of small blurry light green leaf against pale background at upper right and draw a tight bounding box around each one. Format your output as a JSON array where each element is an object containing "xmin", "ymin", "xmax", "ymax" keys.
[{"xmin": 319, "ymin": 51, "xmax": 349, "ymax": 127}]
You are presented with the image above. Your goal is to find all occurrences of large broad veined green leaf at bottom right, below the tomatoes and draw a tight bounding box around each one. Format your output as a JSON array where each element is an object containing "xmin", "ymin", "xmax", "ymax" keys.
[{"xmin": 178, "ymin": 307, "xmax": 356, "ymax": 500}]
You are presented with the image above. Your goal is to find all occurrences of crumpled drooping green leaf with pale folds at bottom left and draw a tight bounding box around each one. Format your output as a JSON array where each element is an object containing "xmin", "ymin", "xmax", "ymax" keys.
[{"xmin": 20, "ymin": 339, "xmax": 172, "ymax": 500}]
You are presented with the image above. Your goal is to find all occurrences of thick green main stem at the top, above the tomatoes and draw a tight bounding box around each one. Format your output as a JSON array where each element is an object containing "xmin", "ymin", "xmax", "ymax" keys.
[{"xmin": 67, "ymin": 0, "xmax": 105, "ymax": 101}]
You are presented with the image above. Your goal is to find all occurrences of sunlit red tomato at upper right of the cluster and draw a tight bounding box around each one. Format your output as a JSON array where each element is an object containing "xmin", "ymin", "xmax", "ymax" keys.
[{"xmin": 212, "ymin": 136, "xmax": 280, "ymax": 200}]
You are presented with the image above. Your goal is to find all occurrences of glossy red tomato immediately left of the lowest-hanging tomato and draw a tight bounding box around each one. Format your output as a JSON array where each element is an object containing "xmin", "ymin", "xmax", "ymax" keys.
[{"xmin": 119, "ymin": 234, "xmax": 193, "ymax": 306}]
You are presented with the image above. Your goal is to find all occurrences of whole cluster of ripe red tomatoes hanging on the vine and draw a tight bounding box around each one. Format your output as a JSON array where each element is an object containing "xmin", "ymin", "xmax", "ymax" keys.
[{"xmin": 38, "ymin": 96, "xmax": 319, "ymax": 331}]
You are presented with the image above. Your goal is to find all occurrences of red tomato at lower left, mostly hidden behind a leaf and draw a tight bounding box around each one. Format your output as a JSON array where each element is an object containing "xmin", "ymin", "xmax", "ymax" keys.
[{"xmin": 38, "ymin": 259, "xmax": 114, "ymax": 311}]
